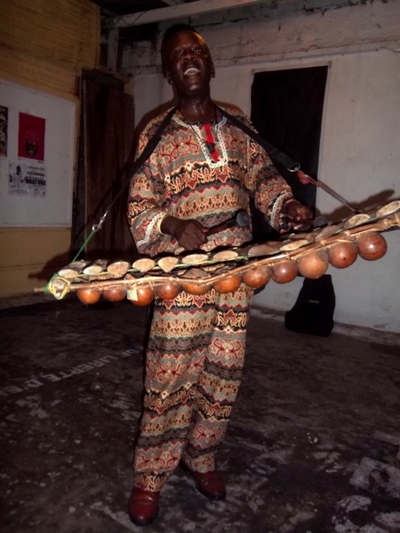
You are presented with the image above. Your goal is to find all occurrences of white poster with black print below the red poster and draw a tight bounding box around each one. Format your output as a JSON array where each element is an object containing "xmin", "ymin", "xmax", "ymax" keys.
[{"xmin": 8, "ymin": 162, "xmax": 47, "ymax": 198}]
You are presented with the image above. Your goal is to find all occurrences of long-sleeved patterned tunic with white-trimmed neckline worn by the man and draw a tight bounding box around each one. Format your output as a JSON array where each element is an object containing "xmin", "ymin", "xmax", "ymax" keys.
[{"xmin": 128, "ymin": 105, "xmax": 292, "ymax": 256}]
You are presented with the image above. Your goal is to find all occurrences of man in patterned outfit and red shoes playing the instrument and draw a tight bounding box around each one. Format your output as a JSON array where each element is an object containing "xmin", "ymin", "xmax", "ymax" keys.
[{"xmin": 128, "ymin": 25, "xmax": 312, "ymax": 525}]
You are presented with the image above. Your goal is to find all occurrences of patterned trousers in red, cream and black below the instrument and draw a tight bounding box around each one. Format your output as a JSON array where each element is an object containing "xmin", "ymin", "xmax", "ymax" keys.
[{"xmin": 134, "ymin": 284, "xmax": 253, "ymax": 491}]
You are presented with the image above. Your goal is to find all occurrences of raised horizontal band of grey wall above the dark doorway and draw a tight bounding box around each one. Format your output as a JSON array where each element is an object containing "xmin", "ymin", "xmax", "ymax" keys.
[{"xmin": 123, "ymin": 0, "xmax": 400, "ymax": 76}]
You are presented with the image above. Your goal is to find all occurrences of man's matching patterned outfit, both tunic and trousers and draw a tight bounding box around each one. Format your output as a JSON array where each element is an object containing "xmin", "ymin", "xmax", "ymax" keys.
[{"xmin": 129, "ymin": 104, "xmax": 292, "ymax": 491}]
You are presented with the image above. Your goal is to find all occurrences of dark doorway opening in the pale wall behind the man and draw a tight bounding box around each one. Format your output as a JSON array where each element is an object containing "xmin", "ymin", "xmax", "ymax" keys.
[{"xmin": 251, "ymin": 66, "xmax": 328, "ymax": 240}]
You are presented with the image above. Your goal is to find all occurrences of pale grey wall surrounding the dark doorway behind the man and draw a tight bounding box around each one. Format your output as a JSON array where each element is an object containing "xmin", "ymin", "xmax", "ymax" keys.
[{"xmin": 124, "ymin": 1, "xmax": 400, "ymax": 332}]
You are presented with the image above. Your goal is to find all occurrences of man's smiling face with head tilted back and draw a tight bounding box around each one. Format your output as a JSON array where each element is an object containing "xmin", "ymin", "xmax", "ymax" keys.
[{"xmin": 166, "ymin": 31, "xmax": 215, "ymax": 96}]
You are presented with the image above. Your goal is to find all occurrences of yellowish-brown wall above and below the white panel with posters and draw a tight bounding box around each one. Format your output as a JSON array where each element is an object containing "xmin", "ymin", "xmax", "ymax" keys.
[{"xmin": 0, "ymin": 0, "xmax": 100, "ymax": 297}]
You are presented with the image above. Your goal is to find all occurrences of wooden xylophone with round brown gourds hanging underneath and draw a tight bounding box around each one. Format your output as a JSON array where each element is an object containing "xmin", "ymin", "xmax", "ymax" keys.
[{"xmin": 36, "ymin": 200, "xmax": 400, "ymax": 306}]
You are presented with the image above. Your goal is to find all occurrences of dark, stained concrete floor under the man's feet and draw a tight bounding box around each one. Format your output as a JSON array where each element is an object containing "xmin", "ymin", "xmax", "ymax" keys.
[{"xmin": 0, "ymin": 296, "xmax": 400, "ymax": 533}]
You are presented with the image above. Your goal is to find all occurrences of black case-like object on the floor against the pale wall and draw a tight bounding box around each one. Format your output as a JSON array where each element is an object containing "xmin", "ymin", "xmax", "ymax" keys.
[{"xmin": 285, "ymin": 274, "xmax": 336, "ymax": 337}]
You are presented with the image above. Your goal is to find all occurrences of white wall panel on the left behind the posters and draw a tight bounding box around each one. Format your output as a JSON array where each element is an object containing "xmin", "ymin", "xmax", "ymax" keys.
[{"xmin": 0, "ymin": 80, "xmax": 76, "ymax": 228}]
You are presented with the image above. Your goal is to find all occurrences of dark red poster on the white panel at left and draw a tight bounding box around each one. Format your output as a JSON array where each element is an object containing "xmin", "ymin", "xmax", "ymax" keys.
[{"xmin": 18, "ymin": 113, "xmax": 46, "ymax": 161}]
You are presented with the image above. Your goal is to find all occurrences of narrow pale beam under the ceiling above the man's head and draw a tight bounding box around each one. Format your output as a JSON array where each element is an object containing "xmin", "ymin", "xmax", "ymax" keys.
[{"xmin": 113, "ymin": 0, "xmax": 266, "ymax": 28}]
